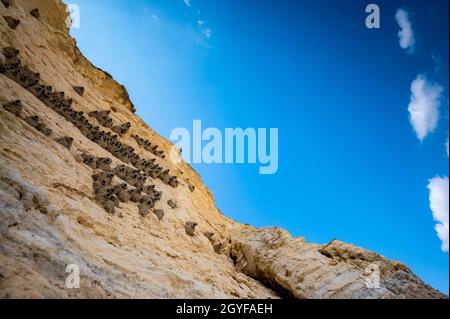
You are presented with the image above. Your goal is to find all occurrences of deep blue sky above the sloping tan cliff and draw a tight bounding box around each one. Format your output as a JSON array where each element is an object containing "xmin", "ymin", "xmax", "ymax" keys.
[{"xmin": 66, "ymin": 0, "xmax": 449, "ymax": 293}]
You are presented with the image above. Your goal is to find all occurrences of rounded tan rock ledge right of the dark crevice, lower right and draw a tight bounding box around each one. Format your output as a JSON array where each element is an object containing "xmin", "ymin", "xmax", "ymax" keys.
[{"xmin": 231, "ymin": 228, "xmax": 445, "ymax": 299}]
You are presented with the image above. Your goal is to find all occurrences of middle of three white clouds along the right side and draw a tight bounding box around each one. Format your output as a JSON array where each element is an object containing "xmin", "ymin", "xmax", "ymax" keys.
[{"xmin": 408, "ymin": 74, "xmax": 443, "ymax": 141}]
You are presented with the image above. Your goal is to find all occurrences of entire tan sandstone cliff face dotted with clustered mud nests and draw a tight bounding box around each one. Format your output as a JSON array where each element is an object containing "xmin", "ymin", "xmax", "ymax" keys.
[{"xmin": 0, "ymin": 0, "xmax": 446, "ymax": 298}]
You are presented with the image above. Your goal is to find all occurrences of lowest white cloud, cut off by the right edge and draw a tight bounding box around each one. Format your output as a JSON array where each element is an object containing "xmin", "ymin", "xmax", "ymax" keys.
[{"xmin": 428, "ymin": 177, "xmax": 449, "ymax": 252}]
